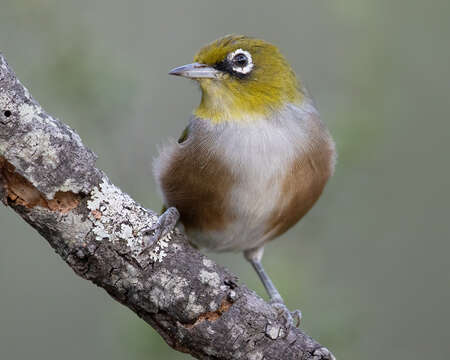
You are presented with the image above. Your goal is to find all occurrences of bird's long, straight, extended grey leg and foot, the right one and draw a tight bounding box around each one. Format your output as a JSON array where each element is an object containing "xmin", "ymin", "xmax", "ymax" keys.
[{"xmin": 244, "ymin": 247, "xmax": 302, "ymax": 326}]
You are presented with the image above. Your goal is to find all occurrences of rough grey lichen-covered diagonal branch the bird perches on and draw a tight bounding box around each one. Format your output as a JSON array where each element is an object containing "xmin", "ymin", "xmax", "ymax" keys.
[{"xmin": 0, "ymin": 54, "xmax": 334, "ymax": 360}]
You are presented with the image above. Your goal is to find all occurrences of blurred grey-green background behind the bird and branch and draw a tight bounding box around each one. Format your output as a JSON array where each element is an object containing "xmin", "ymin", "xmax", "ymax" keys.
[{"xmin": 0, "ymin": 0, "xmax": 450, "ymax": 360}]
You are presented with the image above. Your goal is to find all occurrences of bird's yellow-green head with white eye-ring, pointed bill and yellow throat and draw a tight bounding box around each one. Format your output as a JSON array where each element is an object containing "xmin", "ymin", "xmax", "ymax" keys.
[{"xmin": 169, "ymin": 35, "xmax": 303, "ymax": 123}]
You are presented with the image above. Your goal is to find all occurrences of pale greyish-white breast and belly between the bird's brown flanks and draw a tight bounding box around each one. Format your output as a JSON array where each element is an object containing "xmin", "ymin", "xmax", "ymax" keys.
[{"xmin": 189, "ymin": 102, "xmax": 318, "ymax": 251}]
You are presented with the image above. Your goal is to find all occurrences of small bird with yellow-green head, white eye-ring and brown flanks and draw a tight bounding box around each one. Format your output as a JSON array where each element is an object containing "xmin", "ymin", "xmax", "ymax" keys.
[{"xmin": 152, "ymin": 34, "xmax": 336, "ymax": 325}]
